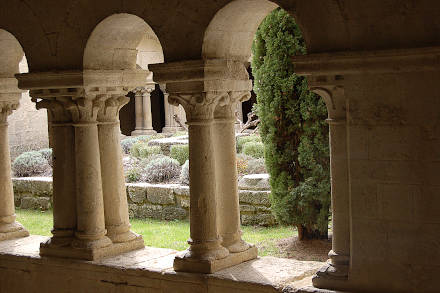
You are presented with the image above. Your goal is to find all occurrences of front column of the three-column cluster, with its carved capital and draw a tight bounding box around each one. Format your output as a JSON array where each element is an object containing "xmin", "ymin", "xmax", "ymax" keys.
[{"xmin": 67, "ymin": 94, "xmax": 112, "ymax": 253}]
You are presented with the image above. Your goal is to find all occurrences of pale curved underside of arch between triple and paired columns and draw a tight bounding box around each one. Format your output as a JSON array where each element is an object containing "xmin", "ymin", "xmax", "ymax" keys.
[{"xmin": 83, "ymin": 13, "xmax": 164, "ymax": 70}]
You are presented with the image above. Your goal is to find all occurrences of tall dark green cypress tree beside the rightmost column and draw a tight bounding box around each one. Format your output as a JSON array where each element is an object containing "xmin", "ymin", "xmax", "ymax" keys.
[{"xmin": 252, "ymin": 8, "xmax": 330, "ymax": 238}]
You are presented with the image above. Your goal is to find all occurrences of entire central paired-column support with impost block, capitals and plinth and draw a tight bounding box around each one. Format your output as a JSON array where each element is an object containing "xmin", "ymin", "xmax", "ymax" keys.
[{"xmin": 150, "ymin": 59, "xmax": 257, "ymax": 273}]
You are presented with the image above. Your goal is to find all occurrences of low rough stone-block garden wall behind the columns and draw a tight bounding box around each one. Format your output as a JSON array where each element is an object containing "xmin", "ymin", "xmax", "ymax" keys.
[{"xmin": 12, "ymin": 177, "xmax": 275, "ymax": 226}]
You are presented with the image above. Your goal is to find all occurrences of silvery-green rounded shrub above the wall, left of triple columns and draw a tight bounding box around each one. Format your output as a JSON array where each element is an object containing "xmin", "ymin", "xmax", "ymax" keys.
[{"xmin": 12, "ymin": 151, "xmax": 50, "ymax": 177}]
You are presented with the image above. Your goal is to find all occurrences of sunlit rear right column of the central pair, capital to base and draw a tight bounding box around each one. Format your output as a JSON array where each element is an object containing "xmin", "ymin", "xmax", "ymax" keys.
[{"xmin": 213, "ymin": 92, "xmax": 251, "ymax": 253}]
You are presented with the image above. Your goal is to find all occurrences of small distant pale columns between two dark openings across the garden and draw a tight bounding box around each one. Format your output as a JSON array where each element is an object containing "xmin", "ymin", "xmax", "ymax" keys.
[{"xmin": 131, "ymin": 85, "xmax": 156, "ymax": 136}]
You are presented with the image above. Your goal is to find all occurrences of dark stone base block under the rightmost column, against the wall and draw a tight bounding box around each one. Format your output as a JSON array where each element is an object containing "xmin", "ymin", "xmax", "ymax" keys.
[{"xmin": 312, "ymin": 264, "xmax": 349, "ymax": 290}]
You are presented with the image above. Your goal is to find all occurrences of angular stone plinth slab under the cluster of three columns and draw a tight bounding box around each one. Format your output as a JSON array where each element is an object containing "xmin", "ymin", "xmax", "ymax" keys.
[{"xmin": 40, "ymin": 236, "xmax": 145, "ymax": 261}]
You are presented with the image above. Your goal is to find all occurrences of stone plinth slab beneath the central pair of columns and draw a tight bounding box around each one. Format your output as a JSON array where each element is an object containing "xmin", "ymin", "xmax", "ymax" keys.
[{"xmin": 174, "ymin": 246, "xmax": 258, "ymax": 274}]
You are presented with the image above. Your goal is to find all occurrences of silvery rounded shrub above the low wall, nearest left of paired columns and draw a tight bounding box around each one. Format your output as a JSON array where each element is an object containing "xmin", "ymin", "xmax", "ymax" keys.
[{"xmin": 142, "ymin": 157, "xmax": 181, "ymax": 183}]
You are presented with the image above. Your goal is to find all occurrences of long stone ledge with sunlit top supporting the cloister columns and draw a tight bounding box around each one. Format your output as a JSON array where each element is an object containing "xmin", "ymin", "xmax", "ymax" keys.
[{"xmin": 0, "ymin": 235, "xmax": 324, "ymax": 293}]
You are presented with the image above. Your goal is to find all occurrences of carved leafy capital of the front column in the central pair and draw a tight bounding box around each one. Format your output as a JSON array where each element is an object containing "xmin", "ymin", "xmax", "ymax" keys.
[{"xmin": 168, "ymin": 92, "xmax": 230, "ymax": 123}]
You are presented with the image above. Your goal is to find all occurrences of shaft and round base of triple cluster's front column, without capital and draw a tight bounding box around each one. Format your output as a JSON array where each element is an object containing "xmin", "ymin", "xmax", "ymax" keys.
[{"xmin": 74, "ymin": 122, "xmax": 111, "ymax": 249}]
